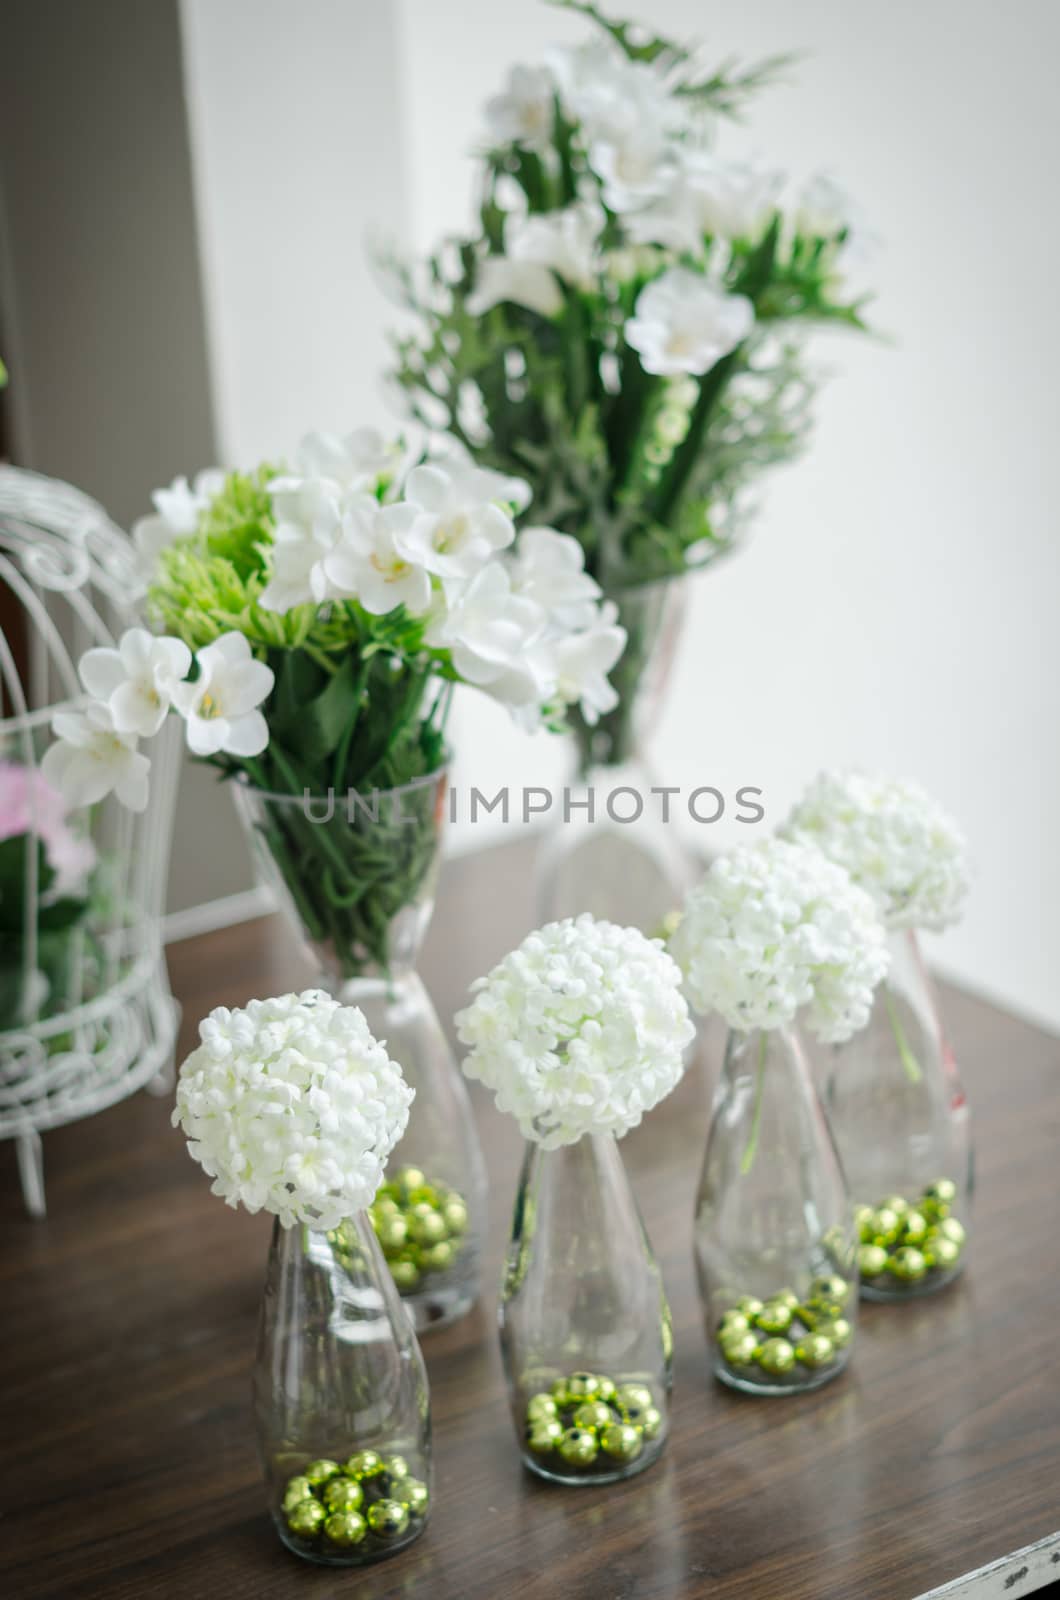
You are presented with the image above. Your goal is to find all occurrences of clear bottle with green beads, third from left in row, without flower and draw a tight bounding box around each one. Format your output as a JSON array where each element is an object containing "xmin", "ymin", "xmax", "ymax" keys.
[{"xmin": 693, "ymin": 1029, "xmax": 857, "ymax": 1395}]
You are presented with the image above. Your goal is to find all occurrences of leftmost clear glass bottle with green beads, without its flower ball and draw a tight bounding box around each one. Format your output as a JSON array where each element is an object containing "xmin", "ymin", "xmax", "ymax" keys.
[{"xmin": 253, "ymin": 1213, "xmax": 431, "ymax": 1566}]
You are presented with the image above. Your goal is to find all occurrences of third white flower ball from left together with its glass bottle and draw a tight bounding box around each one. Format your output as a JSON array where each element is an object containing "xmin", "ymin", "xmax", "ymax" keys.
[{"xmin": 673, "ymin": 840, "xmax": 887, "ymax": 1395}]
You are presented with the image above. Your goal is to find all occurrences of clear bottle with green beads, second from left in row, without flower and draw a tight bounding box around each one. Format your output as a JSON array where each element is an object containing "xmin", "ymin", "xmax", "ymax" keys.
[{"xmin": 500, "ymin": 1134, "xmax": 673, "ymax": 1483}]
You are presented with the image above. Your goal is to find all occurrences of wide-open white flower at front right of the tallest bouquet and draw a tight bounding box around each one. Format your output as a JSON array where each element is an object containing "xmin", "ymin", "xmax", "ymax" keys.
[{"xmin": 626, "ymin": 267, "xmax": 754, "ymax": 378}]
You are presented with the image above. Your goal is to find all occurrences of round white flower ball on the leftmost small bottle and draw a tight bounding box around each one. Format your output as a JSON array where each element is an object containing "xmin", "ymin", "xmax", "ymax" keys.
[{"xmin": 173, "ymin": 989, "xmax": 415, "ymax": 1230}]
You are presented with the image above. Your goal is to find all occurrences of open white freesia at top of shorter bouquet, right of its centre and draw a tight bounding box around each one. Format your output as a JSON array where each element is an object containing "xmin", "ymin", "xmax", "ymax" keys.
[{"xmin": 402, "ymin": 462, "xmax": 516, "ymax": 582}]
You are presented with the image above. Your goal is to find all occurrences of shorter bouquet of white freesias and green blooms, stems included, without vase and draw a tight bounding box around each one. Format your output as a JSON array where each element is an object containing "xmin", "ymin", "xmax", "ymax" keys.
[{"xmin": 43, "ymin": 429, "xmax": 624, "ymax": 979}]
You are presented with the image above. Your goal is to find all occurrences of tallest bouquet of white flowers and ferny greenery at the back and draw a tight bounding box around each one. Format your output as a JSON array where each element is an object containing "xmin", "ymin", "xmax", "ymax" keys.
[{"xmin": 385, "ymin": 0, "xmax": 865, "ymax": 762}]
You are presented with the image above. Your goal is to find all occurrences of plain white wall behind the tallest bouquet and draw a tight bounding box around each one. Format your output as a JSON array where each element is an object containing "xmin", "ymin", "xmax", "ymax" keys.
[{"xmin": 393, "ymin": 0, "xmax": 1060, "ymax": 1024}]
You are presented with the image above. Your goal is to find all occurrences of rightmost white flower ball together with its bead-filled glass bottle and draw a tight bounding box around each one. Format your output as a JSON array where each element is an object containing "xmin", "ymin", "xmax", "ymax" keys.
[{"xmin": 785, "ymin": 773, "xmax": 972, "ymax": 1301}]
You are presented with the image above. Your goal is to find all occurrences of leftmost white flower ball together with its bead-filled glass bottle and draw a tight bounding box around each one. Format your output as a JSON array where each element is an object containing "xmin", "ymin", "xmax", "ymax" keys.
[{"xmin": 173, "ymin": 989, "xmax": 431, "ymax": 1566}]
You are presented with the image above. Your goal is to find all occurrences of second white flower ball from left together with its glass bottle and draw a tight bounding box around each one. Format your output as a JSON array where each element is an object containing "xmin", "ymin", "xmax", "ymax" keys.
[{"xmin": 456, "ymin": 915, "xmax": 693, "ymax": 1483}]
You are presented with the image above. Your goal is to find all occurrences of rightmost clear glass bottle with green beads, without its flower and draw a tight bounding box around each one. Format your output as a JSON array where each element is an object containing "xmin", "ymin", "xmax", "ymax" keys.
[{"xmin": 828, "ymin": 930, "xmax": 974, "ymax": 1301}]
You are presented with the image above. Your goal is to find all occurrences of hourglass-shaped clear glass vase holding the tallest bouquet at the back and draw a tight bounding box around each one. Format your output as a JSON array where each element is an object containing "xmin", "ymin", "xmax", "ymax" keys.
[{"xmin": 538, "ymin": 578, "xmax": 695, "ymax": 934}]
